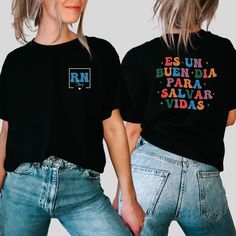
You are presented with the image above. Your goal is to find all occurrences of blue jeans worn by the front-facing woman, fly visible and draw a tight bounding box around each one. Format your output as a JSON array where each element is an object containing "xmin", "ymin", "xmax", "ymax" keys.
[{"xmin": 0, "ymin": 156, "xmax": 130, "ymax": 236}]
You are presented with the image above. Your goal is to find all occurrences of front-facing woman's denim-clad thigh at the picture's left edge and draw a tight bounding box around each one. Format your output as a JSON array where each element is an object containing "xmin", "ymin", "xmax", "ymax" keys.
[{"xmin": 0, "ymin": 165, "xmax": 50, "ymax": 236}]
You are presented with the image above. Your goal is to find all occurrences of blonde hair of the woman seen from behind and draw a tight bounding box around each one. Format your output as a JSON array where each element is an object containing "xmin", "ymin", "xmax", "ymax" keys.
[{"xmin": 153, "ymin": 0, "xmax": 219, "ymax": 50}]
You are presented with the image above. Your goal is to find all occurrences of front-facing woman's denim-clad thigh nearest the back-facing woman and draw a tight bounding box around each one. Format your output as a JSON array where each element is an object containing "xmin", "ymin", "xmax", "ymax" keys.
[{"xmin": 55, "ymin": 170, "xmax": 130, "ymax": 236}]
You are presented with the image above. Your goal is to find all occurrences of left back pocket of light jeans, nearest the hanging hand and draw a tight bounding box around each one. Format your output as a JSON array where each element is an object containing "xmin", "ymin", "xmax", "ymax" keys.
[{"xmin": 132, "ymin": 165, "xmax": 169, "ymax": 216}]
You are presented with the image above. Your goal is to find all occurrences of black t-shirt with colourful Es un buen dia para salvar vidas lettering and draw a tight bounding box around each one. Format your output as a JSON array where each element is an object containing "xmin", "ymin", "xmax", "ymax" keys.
[{"xmin": 122, "ymin": 30, "xmax": 236, "ymax": 170}]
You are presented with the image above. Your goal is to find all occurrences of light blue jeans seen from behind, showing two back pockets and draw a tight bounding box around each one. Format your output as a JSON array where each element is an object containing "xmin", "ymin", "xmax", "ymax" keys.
[{"xmin": 119, "ymin": 138, "xmax": 236, "ymax": 236}]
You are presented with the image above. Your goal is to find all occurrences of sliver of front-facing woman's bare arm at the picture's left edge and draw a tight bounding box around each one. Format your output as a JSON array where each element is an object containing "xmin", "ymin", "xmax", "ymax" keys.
[{"xmin": 0, "ymin": 121, "xmax": 8, "ymax": 190}]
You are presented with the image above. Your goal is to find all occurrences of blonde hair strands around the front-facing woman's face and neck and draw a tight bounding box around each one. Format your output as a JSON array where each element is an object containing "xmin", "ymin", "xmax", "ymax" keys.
[{"xmin": 12, "ymin": 0, "xmax": 91, "ymax": 55}]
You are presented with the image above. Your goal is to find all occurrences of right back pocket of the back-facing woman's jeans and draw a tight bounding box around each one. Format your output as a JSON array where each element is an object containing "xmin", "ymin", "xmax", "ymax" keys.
[{"xmin": 197, "ymin": 171, "xmax": 228, "ymax": 222}]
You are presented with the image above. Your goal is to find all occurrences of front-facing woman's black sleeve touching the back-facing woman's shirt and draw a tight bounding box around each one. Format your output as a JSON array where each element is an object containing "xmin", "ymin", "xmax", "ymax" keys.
[{"xmin": 103, "ymin": 43, "xmax": 123, "ymax": 120}]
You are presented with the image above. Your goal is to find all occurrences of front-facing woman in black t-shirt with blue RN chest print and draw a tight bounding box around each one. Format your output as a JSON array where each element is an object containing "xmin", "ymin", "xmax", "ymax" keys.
[{"xmin": 0, "ymin": 0, "xmax": 144, "ymax": 236}]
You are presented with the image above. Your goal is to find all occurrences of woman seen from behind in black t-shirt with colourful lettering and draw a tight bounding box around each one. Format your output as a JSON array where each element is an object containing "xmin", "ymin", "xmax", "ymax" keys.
[{"xmin": 114, "ymin": 0, "xmax": 236, "ymax": 236}]
